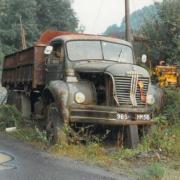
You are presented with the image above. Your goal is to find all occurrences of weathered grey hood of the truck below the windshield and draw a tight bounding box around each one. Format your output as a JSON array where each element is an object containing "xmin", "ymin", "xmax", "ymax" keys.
[{"xmin": 74, "ymin": 61, "xmax": 149, "ymax": 77}]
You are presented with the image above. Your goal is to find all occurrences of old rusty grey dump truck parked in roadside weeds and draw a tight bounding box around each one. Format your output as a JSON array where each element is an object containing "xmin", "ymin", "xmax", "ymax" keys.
[{"xmin": 2, "ymin": 31, "xmax": 154, "ymax": 146}]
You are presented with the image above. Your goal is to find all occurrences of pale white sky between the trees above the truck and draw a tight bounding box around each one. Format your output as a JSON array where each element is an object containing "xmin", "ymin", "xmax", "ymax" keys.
[{"xmin": 72, "ymin": 0, "xmax": 161, "ymax": 34}]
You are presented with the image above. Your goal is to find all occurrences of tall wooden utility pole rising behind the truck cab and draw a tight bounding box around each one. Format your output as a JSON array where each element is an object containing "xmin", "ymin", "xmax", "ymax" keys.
[{"xmin": 125, "ymin": 0, "xmax": 132, "ymax": 42}]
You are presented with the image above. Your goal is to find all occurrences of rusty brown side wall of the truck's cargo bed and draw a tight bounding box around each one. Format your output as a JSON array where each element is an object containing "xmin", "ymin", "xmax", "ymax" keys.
[{"xmin": 2, "ymin": 45, "xmax": 45, "ymax": 88}]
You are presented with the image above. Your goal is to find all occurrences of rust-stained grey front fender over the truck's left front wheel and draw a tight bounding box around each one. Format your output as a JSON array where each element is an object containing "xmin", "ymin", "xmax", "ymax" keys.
[{"xmin": 43, "ymin": 80, "xmax": 69, "ymax": 123}]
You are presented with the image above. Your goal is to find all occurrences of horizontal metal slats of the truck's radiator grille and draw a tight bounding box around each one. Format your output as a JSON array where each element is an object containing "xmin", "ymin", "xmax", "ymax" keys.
[{"xmin": 114, "ymin": 76, "xmax": 149, "ymax": 105}]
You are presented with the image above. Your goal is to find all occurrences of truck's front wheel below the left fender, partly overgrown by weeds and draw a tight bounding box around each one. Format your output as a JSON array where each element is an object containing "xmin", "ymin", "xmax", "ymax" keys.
[{"xmin": 45, "ymin": 103, "xmax": 66, "ymax": 144}]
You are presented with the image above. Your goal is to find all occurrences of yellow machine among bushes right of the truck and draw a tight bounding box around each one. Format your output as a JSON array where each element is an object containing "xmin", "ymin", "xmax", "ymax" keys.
[{"xmin": 154, "ymin": 65, "xmax": 179, "ymax": 88}]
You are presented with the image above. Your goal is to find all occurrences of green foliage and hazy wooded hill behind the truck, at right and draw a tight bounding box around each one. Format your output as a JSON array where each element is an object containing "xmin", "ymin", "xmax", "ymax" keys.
[{"xmin": 105, "ymin": 0, "xmax": 180, "ymax": 65}]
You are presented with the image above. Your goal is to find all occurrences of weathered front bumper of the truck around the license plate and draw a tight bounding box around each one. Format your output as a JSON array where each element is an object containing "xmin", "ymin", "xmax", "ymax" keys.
[{"xmin": 70, "ymin": 105, "xmax": 154, "ymax": 125}]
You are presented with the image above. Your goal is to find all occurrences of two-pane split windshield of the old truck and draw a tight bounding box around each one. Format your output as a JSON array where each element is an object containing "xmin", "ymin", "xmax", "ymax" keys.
[{"xmin": 67, "ymin": 40, "xmax": 133, "ymax": 63}]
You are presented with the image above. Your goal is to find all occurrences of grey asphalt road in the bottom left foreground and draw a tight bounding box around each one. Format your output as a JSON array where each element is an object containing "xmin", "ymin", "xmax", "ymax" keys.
[{"xmin": 0, "ymin": 135, "xmax": 129, "ymax": 180}]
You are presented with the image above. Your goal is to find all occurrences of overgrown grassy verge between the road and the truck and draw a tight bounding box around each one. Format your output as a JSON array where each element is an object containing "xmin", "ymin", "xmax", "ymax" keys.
[{"xmin": 0, "ymin": 90, "xmax": 180, "ymax": 180}]
